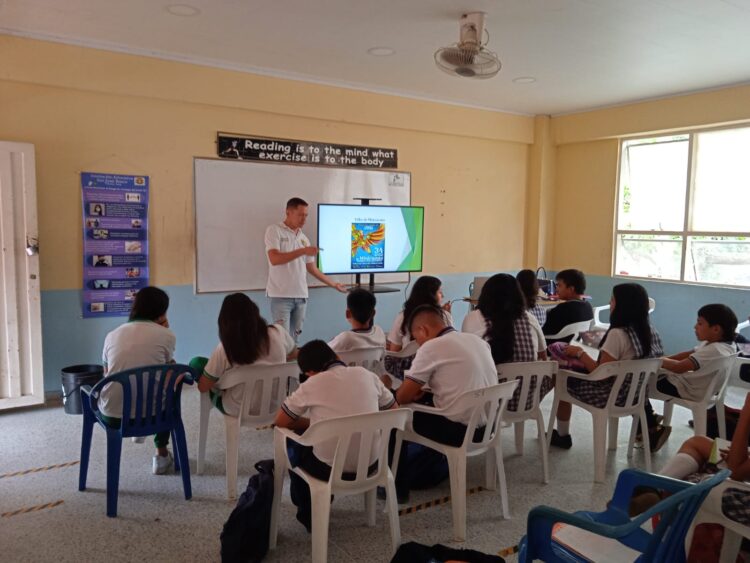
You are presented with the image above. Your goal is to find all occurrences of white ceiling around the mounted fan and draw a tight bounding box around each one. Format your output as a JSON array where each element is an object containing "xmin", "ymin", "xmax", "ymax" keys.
[{"xmin": 0, "ymin": 0, "xmax": 750, "ymax": 114}]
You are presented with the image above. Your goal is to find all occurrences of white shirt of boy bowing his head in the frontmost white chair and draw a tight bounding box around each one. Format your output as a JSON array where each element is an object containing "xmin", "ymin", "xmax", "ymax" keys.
[{"xmin": 281, "ymin": 362, "xmax": 396, "ymax": 471}]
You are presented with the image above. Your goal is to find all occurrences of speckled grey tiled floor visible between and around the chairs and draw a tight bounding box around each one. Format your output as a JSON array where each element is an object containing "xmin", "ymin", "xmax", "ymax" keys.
[{"xmin": 0, "ymin": 388, "xmax": 692, "ymax": 562}]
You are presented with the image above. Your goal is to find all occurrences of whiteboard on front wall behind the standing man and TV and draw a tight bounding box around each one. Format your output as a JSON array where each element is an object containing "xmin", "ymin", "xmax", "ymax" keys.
[{"xmin": 193, "ymin": 158, "xmax": 411, "ymax": 293}]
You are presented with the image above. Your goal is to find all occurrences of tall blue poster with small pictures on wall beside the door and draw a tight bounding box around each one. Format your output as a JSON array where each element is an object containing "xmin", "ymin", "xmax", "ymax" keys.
[{"xmin": 81, "ymin": 172, "xmax": 148, "ymax": 318}]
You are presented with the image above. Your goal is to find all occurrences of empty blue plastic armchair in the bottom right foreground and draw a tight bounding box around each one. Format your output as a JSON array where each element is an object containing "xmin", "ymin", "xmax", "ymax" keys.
[{"xmin": 518, "ymin": 469, "xmax": 729, "ymax": 563}]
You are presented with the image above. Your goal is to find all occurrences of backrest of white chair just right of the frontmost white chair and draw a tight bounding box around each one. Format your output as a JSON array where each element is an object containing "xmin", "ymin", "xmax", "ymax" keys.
[{"xmin": 440, "ymin": 379, "xmax": 518, "ymax": 451}]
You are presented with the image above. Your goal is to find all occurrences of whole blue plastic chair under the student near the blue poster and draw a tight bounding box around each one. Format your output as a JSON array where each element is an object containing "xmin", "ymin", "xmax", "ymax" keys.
[{"xmin": 78, "ymin": 364, "xmax": 198, "ymax": 517}]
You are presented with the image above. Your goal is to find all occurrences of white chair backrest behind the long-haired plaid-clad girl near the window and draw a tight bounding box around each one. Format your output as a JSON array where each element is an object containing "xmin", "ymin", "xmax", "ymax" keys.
[{"xmin": 591, "ymin": 358, "xmax": 661, "ymax": 416}]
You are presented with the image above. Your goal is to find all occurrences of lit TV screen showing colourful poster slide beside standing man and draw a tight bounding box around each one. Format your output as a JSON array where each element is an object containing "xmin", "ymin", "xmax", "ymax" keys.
[{"xmin": 318, "ymin": 203, "xmax": 424, "ymax": 274}]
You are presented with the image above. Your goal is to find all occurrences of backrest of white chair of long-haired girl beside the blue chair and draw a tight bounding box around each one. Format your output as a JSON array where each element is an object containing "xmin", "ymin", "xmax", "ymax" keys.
[{"xmin": 216, "ymin": 362, "xmax": 299, "ymax": 426}]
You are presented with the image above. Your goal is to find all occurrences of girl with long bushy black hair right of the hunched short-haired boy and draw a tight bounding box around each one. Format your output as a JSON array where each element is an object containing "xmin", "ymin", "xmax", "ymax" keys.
[{"xmin": 461, "ymin": 274, "xmax": 554, "ymax": 411}]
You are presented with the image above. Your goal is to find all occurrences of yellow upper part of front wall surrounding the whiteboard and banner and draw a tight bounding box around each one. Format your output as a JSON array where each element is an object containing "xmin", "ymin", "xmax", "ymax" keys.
[{"xmin": 0, "ymin": 36, "xmax": 534, "ymax": 290}]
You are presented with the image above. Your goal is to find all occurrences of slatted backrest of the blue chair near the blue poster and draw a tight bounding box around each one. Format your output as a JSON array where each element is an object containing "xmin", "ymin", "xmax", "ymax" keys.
[{"xmin": 91, "ymin": 364, "xmax": 199, "ymax": 436}]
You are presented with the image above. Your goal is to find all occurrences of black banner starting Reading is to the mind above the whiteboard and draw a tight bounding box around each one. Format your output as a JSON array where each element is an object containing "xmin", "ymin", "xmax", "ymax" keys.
[{"xmin": 216, "ymin": 133, "xmax": 398, "ymax": 168}]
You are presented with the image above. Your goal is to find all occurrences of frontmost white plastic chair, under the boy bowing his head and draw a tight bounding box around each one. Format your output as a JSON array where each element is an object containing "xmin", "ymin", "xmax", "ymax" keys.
[{"xmin": 269, "ymin": 409, "xmax": 412, "ymax": 563}]
